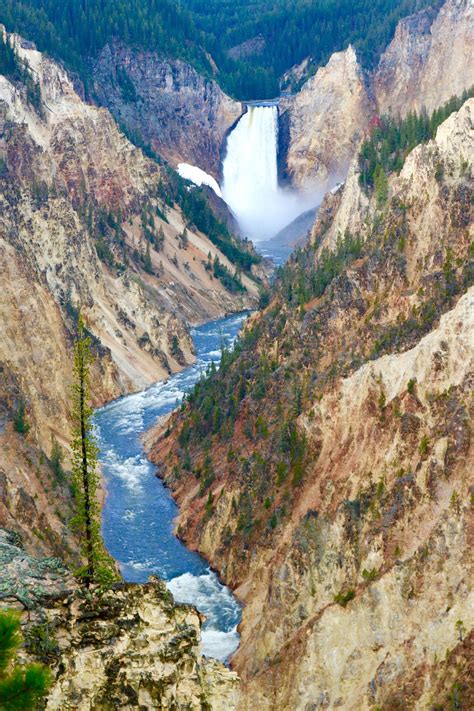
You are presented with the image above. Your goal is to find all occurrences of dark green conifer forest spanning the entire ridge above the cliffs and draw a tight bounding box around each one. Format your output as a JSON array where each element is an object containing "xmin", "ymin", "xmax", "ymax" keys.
[{"xmin": 0, "ymin": 0, "xmax": 439, "ymax": 100}]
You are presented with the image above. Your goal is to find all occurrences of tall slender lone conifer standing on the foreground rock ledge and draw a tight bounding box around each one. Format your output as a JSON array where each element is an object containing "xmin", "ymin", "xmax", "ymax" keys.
[{"xmin": 71, "ymin": 316, "xmax": 117, "ymax": 586}]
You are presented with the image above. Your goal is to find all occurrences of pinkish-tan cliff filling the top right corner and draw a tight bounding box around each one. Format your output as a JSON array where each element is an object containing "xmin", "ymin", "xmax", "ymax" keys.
[{"xmin": 374, "ymin": 0, "xmax": 474, "ymax": 116}]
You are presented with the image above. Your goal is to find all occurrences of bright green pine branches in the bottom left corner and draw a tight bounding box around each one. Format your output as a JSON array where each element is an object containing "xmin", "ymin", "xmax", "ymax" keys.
[{"xmin": 0, "ymin": 610, "xmax": 50, "ymax": 711}]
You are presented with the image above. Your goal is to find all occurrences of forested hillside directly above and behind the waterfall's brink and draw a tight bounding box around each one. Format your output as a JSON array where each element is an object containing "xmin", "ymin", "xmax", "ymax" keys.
[{"xmin": 186, "ymin": 0, "xmax": 440, "ymax": 98}]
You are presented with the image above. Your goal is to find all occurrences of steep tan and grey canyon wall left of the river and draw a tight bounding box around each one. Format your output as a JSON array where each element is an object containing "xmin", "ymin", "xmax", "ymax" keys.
[{"xmin": 0, "ymin": 30, "xmax": 258, "ymax": 551}]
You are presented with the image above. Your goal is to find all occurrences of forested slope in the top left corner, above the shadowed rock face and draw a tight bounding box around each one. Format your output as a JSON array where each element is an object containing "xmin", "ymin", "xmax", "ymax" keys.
[{"xmin": 0, "ymin": 0, "xmax": 210, "ymax": 92}]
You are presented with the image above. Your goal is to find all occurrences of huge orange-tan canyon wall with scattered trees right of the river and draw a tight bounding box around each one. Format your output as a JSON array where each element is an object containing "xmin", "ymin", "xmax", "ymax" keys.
[{"xmin": 152, "ymin": 99, "xmax": 474, "ymax": 711}]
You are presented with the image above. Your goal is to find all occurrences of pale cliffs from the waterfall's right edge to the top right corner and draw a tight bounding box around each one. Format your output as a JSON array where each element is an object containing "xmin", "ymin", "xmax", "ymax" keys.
[{"xmin": 281, "ymin": 0, "xmax": 474, "ymax": 188}]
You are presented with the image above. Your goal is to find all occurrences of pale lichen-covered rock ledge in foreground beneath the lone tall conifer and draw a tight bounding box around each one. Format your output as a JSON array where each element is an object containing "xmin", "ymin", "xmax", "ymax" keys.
[{"xmin": 0, "ymin": 529, "xmax": 238, "ymax": 711}]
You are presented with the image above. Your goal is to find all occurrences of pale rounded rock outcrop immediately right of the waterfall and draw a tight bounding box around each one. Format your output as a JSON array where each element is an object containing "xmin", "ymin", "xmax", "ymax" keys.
[{"xmin": 280, "ymin": 47, "xmax": 372, "ymax": 189}]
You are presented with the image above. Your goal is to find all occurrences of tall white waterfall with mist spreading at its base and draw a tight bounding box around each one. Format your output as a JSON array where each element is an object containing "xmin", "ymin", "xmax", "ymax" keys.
[{"xmin": 222, "ymin": 105, "xmax": 319, "ymax": 242}]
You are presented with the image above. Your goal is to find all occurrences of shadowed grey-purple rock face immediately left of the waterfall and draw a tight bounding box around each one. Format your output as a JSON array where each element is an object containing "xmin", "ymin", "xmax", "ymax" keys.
[{"xmin": 94, "ymin": 43, "xmax": 242, "ymax": 178}]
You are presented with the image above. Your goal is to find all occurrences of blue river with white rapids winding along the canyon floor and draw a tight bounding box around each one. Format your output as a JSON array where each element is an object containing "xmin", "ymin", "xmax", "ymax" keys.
[{"xmin": 95, "ymin": 314, "xmax": 246, "ymax": 661}]
